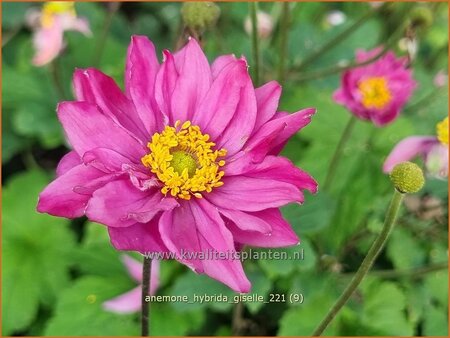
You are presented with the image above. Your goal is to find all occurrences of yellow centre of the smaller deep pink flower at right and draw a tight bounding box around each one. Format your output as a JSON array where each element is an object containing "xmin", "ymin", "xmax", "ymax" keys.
[{"xmin": 358, "ymin": 77, "xmax": 392, "ymax": 109}]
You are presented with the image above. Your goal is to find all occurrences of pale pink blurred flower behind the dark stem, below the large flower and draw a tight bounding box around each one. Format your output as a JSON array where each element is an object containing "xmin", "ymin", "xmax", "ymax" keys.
[{"xmin": 103, "ymin": 255, "xmax": 160, "ymax": 313}]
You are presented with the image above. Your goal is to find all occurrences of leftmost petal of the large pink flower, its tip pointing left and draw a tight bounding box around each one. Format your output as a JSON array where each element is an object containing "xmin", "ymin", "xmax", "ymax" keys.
[{"xmin": 37, "ymin": 164, "xmax": 113, "ymax": 218}]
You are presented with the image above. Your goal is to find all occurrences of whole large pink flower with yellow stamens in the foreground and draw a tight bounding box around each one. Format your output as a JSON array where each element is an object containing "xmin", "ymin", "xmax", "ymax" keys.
[{"xmin": 38, "ymin": 36, "xmax": 317, "ymax": 292}]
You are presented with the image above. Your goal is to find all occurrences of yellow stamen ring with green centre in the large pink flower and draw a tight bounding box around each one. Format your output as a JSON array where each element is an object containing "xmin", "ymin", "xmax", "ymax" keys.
[{"xmin": 141, "ymin": 121, "xmax": 227, "ymax": 200}]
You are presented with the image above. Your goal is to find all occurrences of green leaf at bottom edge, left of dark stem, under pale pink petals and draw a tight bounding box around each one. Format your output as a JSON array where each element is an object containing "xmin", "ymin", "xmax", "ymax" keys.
[{"xmin": 45, "ymin": 277, "xmax": 139, "ymax": 336}]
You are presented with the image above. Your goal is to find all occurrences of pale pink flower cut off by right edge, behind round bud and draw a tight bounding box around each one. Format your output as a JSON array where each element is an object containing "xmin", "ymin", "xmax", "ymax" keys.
[{"xmin": 383, "ymin": 117, "xmax": 448, "ymax": 178}]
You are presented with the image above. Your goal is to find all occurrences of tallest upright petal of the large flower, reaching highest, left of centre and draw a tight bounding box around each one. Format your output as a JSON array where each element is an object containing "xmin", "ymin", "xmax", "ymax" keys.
[{"xmin": 125, "ymin": 35, "xmax": 163, "ymax": 135}]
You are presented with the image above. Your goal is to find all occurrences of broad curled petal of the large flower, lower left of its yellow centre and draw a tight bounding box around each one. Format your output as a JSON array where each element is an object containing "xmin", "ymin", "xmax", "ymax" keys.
[{"xmin": 86, "ymin": 178, "xmax": 178, "ymax": 227}]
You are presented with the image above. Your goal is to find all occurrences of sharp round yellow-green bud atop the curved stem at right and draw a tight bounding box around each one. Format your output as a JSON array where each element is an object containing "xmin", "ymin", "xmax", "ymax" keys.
[{"xmin": 390, "ymin": 162, "xmax": 425, "ymax": 194}]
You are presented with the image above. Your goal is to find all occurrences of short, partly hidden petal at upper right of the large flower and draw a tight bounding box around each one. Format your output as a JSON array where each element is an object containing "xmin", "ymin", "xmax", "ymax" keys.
[{"xmin": 255, "ymin": 81, "xmax": 281, "ymax": 130}]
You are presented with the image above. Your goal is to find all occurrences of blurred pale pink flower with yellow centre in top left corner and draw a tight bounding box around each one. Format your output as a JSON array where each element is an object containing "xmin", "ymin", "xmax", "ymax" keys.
[{"xmin": 27, "ymin": 1, "xmax": 91, "ymax": 66}]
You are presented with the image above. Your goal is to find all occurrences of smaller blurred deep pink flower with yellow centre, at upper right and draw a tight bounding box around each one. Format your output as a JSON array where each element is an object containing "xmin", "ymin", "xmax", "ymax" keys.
[{"xmin": 333, "ymin": 48, "xmax": 416, "ymax": 126}]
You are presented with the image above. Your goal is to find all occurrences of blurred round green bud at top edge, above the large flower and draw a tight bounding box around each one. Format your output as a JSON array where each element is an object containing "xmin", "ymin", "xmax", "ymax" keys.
[{"xmin": 181, "ymin": 1, "xmax": 220, "ymax": 31}]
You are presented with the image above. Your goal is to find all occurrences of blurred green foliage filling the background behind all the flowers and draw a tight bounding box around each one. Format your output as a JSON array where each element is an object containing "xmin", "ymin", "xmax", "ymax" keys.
[{"xmin": 2, "ymin": 2, "xmax": 448, "ymax": 336}]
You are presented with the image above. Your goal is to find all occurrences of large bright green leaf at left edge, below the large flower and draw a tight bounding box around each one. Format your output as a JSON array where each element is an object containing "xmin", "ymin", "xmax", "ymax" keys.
[{"xmin": 2, "ymin": 171, "xmax": 74, "ymax": 335}]
